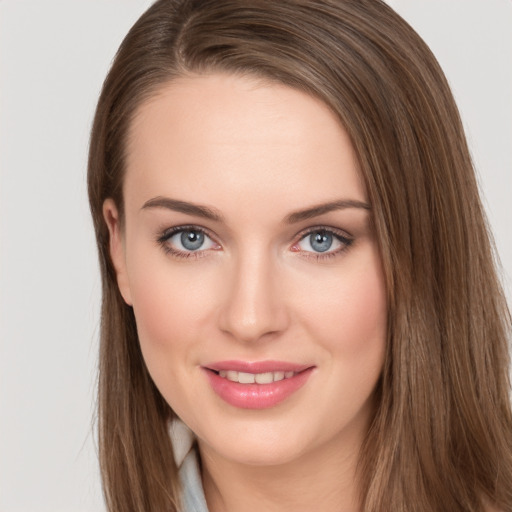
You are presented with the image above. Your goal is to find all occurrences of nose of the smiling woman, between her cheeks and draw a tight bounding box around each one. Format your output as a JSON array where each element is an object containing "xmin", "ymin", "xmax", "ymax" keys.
[{"xmin": 219, "ymin": 249, "xmax": 289, "ymax": 342}]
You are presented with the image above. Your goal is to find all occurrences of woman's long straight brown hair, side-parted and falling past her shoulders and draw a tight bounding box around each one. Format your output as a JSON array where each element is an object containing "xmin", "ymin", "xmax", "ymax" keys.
[{"xmin": 88, "ymin": 0, "xmax": 512, "ymax": 512}]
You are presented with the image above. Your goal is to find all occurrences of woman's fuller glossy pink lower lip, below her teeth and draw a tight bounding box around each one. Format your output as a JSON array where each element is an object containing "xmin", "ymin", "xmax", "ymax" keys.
[{"xmin": 205, "ymin": 368, "xmax": 313, "ymax": 409}]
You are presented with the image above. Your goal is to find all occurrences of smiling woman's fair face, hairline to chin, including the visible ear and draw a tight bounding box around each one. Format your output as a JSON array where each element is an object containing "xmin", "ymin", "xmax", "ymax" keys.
[{"xmin": 104, "ymin": 75, "xmax": 387, "ymax": 464}]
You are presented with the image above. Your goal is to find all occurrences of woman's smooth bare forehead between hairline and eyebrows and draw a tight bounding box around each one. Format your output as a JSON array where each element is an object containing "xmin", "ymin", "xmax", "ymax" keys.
[{"xmin": 125, "ymin": 74, "xmax": 365, "ymax": 213}]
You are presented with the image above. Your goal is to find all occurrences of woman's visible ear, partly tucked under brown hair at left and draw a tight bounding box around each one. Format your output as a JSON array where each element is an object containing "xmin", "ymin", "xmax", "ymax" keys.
[{"xmin": 103, "ymin": 198, "xmax": 132, "ymax": 306}]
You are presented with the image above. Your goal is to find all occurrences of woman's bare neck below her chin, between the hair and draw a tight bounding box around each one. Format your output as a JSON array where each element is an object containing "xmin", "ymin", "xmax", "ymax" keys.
[{"xmin": 199, "ymin": 432, "xmax": 361, "ymax": 512}]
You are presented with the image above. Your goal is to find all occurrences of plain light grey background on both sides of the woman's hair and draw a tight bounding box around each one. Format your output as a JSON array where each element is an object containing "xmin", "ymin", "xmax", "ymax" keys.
[{"xmin": 0, "ymin": 0, "xmax": 512, "ymax": 512}]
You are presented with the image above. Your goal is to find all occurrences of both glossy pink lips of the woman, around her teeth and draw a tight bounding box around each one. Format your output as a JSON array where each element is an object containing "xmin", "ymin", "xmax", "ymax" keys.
[{"xmin": 203, "ymin": 361, "xmax": 314, "ymax": 409}]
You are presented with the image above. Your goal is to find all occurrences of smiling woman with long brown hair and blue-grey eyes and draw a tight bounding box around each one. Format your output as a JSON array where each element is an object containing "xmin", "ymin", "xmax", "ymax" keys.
[{"xmin": 89, "ymin": 0, "xmax": 512, "ymax": 512}]
